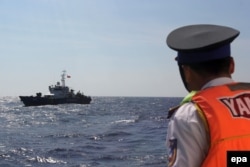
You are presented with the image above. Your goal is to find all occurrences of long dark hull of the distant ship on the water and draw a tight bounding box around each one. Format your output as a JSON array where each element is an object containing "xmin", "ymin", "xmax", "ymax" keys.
[{"xmin": 19, "ymin": 96, "xmax": 91, "ymax": 106}]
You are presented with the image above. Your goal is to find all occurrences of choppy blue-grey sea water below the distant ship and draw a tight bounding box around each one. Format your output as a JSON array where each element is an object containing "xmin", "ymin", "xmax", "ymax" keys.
[{"xmin": 0, "ymin": 97, "xmax": 181, "ymax": 167}]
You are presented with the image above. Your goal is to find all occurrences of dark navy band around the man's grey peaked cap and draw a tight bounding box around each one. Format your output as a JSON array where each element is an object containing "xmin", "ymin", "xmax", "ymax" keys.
[{"xmin": 176, "ymin": 44, "xmax": 231, "ymax": 64}]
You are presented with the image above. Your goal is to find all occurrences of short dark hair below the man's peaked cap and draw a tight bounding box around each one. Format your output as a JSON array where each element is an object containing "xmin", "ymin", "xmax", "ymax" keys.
[{"xmin": 188, "ymin": 57, "xmax": 232, "ymax": 75}]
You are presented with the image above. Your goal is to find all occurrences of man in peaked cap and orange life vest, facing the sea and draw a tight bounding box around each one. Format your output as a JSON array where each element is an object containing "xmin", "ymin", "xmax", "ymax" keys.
[{"xmin": 167, "ymin": 24, "xmax": 250, "ymax": 167}]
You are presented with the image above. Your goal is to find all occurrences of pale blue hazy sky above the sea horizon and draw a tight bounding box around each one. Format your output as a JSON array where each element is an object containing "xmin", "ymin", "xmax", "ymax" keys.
[{"xmin": 0, "ymin": 0, "xmax": 250, "ymax": 97}]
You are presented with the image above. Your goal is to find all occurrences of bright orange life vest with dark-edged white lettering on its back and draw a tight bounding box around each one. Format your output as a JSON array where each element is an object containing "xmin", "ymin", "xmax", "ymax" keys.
[{"xmin": 192, "ymin": 83, "xmax": 250, "ymax": 167}]
